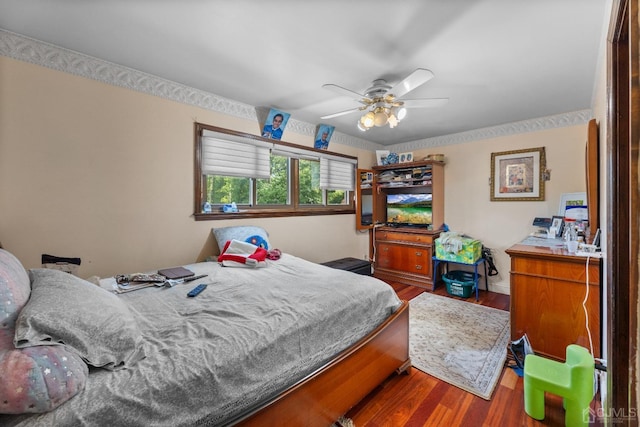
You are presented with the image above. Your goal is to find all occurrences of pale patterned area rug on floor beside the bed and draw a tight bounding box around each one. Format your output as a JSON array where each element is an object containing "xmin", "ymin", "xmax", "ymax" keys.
[{"xmin": 409, "ymin": 292, "xmax": 509, "ymax": 400}]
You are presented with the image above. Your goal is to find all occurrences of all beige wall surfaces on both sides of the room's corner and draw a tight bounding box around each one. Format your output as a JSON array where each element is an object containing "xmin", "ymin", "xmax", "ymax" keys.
[{"xmin": 0, "ymin": 57, "xmax": 586, "ymax": 293}]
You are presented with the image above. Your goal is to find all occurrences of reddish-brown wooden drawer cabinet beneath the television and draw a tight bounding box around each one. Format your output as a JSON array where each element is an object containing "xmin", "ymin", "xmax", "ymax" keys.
[{"xmin": 373, "ymin": 227, "xmax": 440, "ymax": 290}]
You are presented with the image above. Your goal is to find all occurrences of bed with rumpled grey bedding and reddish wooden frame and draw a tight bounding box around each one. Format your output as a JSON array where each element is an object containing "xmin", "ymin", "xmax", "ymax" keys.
[{"xmin": 0, "ymin": 246, "xmax": 410, "ymax": 427}]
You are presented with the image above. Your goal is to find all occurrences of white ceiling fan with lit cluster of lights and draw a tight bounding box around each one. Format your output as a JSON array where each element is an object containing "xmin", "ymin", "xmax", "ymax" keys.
[{"xmin": 322, "ymin": 68, "xmax": 449, "ymax": 131}]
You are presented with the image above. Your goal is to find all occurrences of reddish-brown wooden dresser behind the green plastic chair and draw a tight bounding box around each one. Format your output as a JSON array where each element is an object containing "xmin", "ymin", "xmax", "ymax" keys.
[{"xmin": 506, "ymin": 244, "xmax": 602, "ymax": 360}]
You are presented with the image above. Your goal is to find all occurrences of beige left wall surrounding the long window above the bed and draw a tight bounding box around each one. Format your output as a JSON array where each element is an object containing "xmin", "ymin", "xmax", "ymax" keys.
[{"xmin": 0, "ymin": 56, "xmax": 373, "ymax": 277}]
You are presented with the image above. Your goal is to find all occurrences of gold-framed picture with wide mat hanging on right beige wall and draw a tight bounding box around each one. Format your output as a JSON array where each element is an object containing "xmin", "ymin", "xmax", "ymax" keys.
[{"xmin": 490, "ymin": 147, "xmax": 546, "ymax": 201}]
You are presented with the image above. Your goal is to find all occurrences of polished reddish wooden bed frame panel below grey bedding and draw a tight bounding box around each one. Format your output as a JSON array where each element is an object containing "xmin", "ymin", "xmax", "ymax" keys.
[{"xmin": 234, "ymin": 301, "xmax": 411, "ymax": 427}]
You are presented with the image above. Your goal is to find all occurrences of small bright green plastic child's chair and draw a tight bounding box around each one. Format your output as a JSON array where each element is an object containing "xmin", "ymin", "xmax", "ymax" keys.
[{"xmin": 524, "ymin": 344, "xmax": 595, "ymax": 427}]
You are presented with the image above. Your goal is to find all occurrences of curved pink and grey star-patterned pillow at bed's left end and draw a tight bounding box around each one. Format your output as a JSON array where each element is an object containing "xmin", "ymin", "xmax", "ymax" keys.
[{"xmin": 0, "ymin": 249, "xmax": 89, "ymax": 414}]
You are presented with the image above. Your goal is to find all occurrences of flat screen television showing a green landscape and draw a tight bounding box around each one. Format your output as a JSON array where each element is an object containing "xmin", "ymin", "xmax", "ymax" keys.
[{"xmin": 387, "ymin": 193, "xmax": 433, "ymax": 227}]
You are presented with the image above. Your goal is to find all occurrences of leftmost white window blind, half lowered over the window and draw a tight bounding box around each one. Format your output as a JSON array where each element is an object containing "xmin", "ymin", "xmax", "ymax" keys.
[{"xmin": 202, "ymin": 134, "xmax": 271, "ymax": 179}]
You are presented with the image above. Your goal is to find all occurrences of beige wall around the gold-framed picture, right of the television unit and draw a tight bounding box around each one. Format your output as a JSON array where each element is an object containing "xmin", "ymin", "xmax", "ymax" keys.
[{"xmin": 402, "ymin": 124, "xmax": 587, "ymax": 293}]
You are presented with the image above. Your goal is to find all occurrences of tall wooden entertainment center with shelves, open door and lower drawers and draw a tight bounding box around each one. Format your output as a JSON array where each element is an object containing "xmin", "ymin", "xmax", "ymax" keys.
[{"xmin": 356, "ymin": 161, "xmax": 444, "ymax": 290}]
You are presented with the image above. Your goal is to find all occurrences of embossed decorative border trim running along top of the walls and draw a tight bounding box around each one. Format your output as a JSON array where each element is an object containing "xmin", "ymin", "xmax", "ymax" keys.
[{"xmin": 0, "ymin": 29, "xmax": 592, "ymax": 152}]
